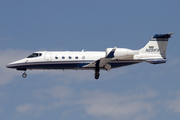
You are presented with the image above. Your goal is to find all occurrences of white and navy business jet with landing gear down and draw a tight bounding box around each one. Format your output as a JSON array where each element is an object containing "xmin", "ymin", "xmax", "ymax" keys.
[{"xmin": 6, "ymin": 33, "xmax": 173, "ymax": 79}]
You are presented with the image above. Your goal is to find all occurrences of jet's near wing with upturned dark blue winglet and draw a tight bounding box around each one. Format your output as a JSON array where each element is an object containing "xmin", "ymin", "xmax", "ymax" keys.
[{"xmin": 83, "ymin": 47, "xmax": 116, "ymax": 71}]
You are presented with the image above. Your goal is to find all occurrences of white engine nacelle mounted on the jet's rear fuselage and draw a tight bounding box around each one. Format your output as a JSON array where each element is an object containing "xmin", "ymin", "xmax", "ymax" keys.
[{"xmin": 106, "ymin": 48, "xmax": 134, "ymax": 59}]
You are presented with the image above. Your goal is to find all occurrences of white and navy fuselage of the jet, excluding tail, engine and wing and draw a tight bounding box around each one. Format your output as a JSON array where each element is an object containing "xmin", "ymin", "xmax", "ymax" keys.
[{"xmin": 7, "ymin": 51, "xmax": 142, "ymax": 70}]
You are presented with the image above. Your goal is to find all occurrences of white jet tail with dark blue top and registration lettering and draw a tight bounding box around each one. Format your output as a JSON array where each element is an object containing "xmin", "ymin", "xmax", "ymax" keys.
[{"xmin": 134, "ymin": 33, "xmax": 173, "ymax": 64}]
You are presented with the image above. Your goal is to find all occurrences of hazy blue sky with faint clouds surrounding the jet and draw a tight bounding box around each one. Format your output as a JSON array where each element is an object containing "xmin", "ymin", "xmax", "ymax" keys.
[{"xmin": 0, "ymin": 0, "xmax": 180, "ymax": 120}]
